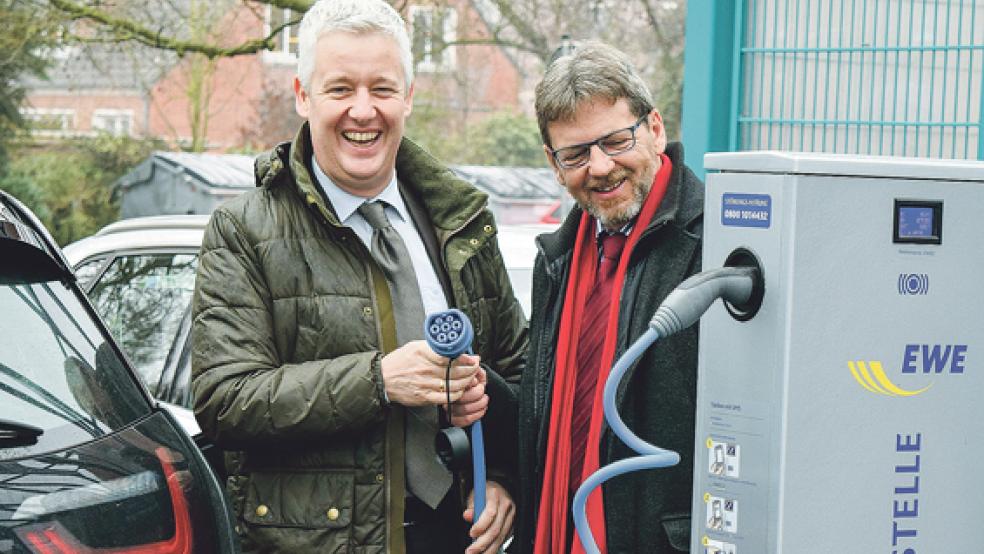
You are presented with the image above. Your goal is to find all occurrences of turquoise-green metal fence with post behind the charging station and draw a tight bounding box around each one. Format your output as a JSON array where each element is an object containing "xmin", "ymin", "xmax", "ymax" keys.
[{"xmin": 683, "ymin": 0, "xmax": 984, "ymax": 175}]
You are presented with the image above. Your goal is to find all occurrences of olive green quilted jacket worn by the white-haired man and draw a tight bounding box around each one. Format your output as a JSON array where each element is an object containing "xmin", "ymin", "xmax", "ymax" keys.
[{"xmin": 192, "ymin": 125, "xmax": 528, "ymax": 553}]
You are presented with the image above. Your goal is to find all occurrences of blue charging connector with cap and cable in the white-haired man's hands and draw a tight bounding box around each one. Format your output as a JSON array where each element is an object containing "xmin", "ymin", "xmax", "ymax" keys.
[{"xmin": 424, "ymin": 308, "xmax": 485, "ymax": 522}]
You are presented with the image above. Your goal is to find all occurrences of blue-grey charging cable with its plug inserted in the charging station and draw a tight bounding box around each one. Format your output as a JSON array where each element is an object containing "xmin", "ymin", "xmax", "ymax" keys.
[{"xmin": 572, "ymin": 267, "xmax": 762, "ymax": 554}]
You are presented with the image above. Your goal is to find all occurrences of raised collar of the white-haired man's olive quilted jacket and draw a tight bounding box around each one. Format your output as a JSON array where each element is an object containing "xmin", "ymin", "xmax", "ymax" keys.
[{"xmin": 254, "ymin": 122, "xmax": 488, "ymax": 231}]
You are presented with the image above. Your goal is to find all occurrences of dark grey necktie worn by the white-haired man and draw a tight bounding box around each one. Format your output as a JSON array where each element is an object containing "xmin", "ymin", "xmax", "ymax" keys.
[{"xmin": 359, "ymin": 201, "xmax": 452, "ymax": 508}]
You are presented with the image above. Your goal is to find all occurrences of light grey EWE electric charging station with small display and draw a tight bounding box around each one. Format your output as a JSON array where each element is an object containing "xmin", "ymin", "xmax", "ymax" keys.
[{"xmin": 691, "ymin": 152, "xmax": 984, "ymax": 554}]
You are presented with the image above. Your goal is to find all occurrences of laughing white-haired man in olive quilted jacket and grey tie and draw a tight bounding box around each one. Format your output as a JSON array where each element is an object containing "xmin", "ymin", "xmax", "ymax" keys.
[{"xmin": 192, "ymin": 0, "xmax": 527, "ymax": 554}]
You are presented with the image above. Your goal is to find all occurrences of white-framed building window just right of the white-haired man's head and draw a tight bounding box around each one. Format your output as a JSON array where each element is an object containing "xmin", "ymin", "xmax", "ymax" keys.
[{"xmin": 410, "ymin": 6, "xmax": 458, "ymax": 73}]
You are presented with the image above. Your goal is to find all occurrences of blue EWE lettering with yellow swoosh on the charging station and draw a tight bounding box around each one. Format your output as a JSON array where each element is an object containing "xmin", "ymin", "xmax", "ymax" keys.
[{"xmin": 847, "ymin": 344, "xmax": 967, "ymax": 398}]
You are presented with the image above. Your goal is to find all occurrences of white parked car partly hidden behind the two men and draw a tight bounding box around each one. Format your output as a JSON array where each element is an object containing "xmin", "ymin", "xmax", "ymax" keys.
[{"xmin": 64, "ymin": 215, "xmax": 556, "ymax": 412}]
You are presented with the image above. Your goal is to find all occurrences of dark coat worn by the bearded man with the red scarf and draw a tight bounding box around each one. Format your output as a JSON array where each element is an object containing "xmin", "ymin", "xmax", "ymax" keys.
[{"xmin": 513, "ymin": 143, "xmax": 704, "ymax": 554}]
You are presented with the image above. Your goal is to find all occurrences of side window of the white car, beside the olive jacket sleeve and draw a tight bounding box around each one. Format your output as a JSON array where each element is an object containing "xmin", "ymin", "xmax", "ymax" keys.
[{"xmin": 89, "ymin": 254, "xmax": 198, "ymax": 395}]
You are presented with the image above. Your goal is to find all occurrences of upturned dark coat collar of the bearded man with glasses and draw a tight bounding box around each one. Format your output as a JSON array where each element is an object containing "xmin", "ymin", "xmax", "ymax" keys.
[{"xmin": 536, "ymin": 142, "xmax": 704, "ymax": 264}]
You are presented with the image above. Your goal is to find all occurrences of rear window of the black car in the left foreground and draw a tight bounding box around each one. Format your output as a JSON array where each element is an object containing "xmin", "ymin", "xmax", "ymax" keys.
[{"xmin": 0, "ymin": 281, "xmax": 150, "ymax": 459}]
